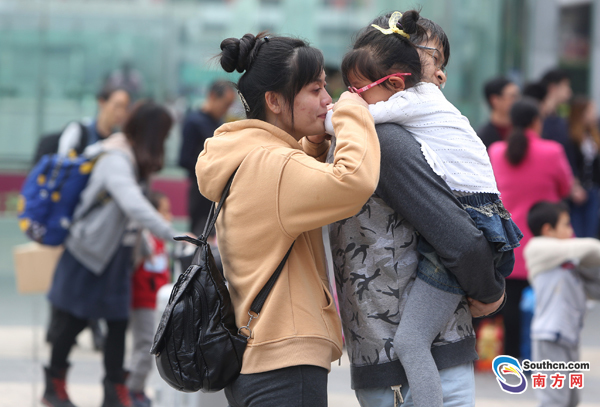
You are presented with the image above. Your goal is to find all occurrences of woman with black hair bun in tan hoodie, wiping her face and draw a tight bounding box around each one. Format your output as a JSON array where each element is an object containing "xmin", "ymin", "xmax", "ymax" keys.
[{"xmin": 196, "ymin": 33, "xmax": 380, "ymax": 407}]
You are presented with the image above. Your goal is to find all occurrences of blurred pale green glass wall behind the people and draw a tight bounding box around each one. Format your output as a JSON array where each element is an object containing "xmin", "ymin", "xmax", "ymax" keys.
[{"xmin": 0, "ymin": 0, "xmax": 521, "ymax": 170}]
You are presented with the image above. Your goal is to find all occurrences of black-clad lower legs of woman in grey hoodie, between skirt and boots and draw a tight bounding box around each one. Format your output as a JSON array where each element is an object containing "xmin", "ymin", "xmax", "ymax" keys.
[{"xmin": 50, "ymin": 309, "xmax": 127, "ymax": 383}]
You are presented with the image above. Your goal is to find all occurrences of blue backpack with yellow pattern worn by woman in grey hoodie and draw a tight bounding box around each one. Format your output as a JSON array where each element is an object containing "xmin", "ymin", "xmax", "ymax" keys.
[{"xmin": 18, "ymin": 154, "xmax": 104, "ymax": 246}]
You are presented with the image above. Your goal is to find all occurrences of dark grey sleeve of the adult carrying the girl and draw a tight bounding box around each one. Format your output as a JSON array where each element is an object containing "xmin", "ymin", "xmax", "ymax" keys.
[{"xmin": 376, "ymin": 124, "xmax": 504, "ymax": 303}]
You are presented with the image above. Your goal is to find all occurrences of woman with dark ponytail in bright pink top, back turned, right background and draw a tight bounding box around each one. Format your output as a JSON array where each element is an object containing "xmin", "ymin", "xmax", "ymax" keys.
[{"xmin": 488, "ymin": 98, "xmax": 573, "ymax": 358}]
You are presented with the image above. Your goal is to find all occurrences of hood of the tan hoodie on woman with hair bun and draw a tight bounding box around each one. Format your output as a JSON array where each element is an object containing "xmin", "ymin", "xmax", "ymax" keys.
[{"xmin": 196, "ymin": 119, "xmax": 302, "ymax": 202}]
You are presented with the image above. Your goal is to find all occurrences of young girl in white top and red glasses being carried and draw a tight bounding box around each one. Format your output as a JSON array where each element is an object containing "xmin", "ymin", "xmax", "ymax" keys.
[{"xmin": 326, "ymin": 11, "xmax": 522, "ymax": 407}]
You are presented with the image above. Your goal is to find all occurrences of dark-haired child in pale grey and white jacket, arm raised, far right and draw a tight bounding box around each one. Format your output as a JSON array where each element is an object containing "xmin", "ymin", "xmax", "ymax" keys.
[{"xmin": 523, "ymin": 201, "xmax": 600, "ymax": 407}]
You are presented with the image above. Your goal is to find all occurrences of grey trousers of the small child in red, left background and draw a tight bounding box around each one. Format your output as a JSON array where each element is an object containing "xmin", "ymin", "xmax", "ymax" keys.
[{"xmin": 127, "ymin": 308, "xmax": 156, "ymax": 392}]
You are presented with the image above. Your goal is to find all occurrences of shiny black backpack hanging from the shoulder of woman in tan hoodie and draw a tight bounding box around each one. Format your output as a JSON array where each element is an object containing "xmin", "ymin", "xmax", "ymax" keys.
[{"xmin": 150, "ymin": 173, "xmax": 294, "ymax": 392}]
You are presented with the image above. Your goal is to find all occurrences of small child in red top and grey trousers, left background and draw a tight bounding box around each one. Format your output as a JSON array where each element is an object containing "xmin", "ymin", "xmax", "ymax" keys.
[{"xmin": 127, "ymin": 191, "xmax": 173, "ymax": 407}]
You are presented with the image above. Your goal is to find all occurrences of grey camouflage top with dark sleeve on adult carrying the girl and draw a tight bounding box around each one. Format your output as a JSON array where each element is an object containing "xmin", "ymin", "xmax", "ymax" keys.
[{"xmin": 330, "ymin": 124, "xmax": 504, "ymax": 389}]
